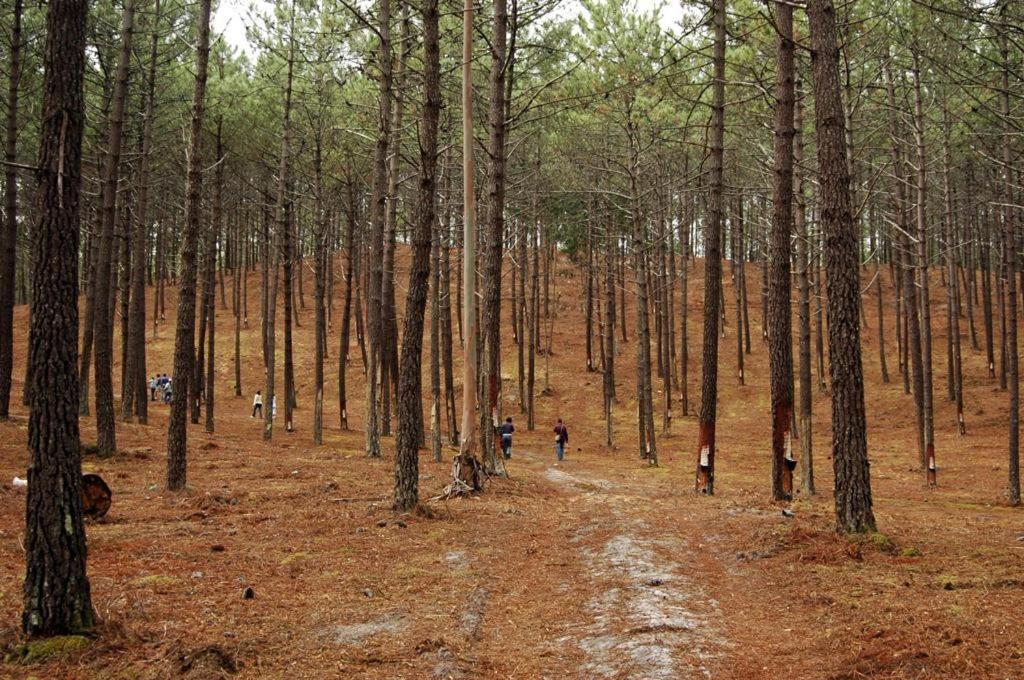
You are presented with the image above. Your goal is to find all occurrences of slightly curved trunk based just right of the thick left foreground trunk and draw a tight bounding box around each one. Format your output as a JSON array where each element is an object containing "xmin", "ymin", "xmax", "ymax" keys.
[{"xmin": 93, "ymin": 0, "xmax": 135, "ymax": 456}]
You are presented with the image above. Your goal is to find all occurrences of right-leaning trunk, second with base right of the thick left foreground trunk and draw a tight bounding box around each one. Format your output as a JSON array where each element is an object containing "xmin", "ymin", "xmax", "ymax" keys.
[{"xmin": 167, "ymin": 0, "xmax": 210, "ymax": 491}]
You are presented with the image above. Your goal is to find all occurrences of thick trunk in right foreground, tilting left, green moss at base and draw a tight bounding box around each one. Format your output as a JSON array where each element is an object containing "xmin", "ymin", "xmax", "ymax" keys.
[{"xmin": 807, "ymin": 0, "xmax": 874, "ymax": 532}]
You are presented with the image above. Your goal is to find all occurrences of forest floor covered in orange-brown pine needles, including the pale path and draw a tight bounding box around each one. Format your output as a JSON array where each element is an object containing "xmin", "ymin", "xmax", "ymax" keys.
[{"xmin": 0, "ymin": 251, "xmax": 1024, "ymax": 680}]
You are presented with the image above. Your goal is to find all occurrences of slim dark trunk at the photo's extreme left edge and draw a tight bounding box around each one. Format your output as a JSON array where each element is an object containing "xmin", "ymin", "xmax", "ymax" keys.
[{"xmin": 0, "ymin": 0, "xmax": 23, "ymax": 420}]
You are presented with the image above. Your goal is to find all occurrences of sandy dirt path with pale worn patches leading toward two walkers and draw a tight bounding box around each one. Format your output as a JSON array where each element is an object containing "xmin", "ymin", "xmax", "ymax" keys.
[{"xmin": 522, "ymin": 452, "xmax": 728, "ymax": 678}]
